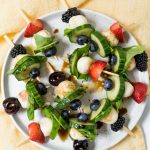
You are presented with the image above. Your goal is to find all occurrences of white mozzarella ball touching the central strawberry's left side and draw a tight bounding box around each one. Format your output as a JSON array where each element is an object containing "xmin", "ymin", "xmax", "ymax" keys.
[{"xmin": 77, "ymin": 57, "xmax": 94, "ymax": 74}]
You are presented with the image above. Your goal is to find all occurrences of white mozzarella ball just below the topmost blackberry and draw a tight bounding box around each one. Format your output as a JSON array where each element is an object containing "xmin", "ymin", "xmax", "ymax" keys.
[{"xmin": 69, "ymin": 15, "xmax": 88, "ymax": 29}]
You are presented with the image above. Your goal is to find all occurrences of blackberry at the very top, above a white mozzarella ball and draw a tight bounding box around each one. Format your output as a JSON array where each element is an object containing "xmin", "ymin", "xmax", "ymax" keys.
[{"xmin": 61, "ymin": 7, "xmax": 80, "ymax": 23}]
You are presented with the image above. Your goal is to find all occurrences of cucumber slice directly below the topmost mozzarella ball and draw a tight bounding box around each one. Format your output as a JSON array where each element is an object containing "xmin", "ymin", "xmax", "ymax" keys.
[{"xmin": 65, "ymin": 24, "xmax": 94, "ymax": 43}]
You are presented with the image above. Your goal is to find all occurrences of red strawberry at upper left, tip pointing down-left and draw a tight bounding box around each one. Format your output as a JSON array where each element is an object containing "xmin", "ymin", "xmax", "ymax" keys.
[{"xmin": 24, "ymin": 19, "xmax": 44, "ymax": 37}]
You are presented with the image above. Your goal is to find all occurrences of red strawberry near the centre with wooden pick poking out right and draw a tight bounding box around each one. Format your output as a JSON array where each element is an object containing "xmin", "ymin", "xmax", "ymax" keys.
[{"xmin": 90, "ymin": 60, "xmax": 107, "ymax": 80}]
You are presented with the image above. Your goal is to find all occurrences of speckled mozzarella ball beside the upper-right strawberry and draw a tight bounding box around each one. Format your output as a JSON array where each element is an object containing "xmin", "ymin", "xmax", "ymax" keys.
[{"xmin": 102, "ymin": 29, "xmax": 119, "ymax": 46}]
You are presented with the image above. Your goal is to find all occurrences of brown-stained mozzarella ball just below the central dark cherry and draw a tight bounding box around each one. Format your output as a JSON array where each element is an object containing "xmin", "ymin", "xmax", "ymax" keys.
[{"xmin": 55, "ymin": 80, "xmax": 76, "ymax": 98}]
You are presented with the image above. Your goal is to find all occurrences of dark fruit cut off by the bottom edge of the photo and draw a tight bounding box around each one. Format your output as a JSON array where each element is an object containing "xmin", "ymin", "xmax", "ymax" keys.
[{"xmin": 73, "ymin": 140, "xmax": 89, "ymax": 150}]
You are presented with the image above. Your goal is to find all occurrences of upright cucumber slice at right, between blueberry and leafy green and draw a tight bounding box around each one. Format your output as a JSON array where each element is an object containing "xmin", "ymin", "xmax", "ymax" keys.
[{"xmin": 112, "ymin": 47, "xmax": 126, "ymax": 73}]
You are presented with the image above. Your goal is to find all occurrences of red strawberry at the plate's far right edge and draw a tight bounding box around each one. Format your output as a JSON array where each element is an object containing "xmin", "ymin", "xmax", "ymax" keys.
[{"xmin": 132, "ymin": 82, "xmax": 147, "ymax": 104}]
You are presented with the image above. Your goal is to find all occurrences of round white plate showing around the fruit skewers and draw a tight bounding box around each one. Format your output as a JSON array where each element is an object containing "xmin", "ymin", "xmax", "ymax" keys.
[{"xmin": 2, "ymin": 10, "xmax": 149, "ymax": 150}]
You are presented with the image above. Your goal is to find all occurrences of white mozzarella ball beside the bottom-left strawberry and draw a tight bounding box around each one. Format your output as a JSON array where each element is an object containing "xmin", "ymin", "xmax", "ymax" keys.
[{"xmin": 39, "ymin": 117, "xmax": 52, "ymax": 136}]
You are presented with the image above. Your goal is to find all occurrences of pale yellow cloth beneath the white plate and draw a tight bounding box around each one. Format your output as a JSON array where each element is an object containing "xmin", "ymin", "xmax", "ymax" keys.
[{"xmin": 0, "ymin": 0, "xmax": 150, "ymax": 150}]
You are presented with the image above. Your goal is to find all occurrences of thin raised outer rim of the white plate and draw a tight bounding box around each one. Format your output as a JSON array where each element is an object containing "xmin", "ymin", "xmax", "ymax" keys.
[{"xmin": 1, "ymin": 8, "xmax": 149, "ymax": 150}]
